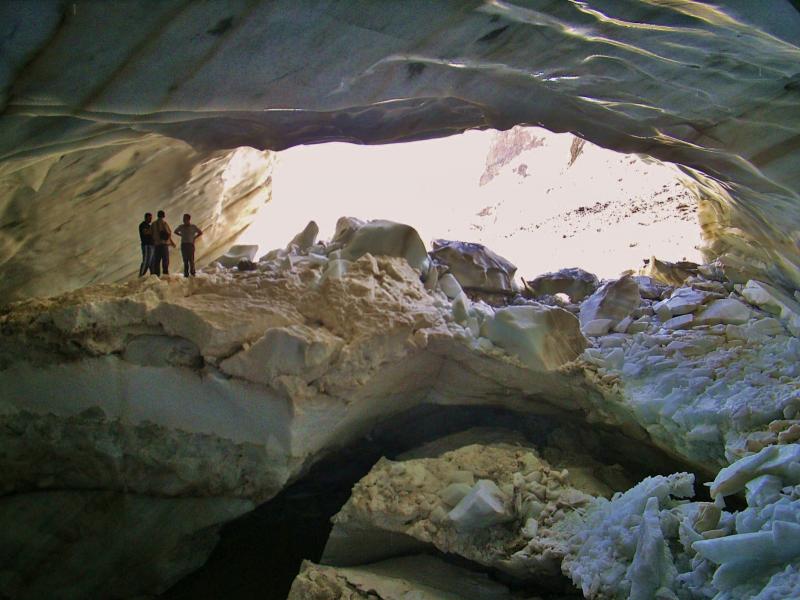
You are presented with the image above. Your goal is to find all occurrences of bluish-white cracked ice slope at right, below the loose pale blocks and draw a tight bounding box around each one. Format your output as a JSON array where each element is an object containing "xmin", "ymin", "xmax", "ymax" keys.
[{"xmin": 584, "ymin": 300, "xmax": 800, "ymax": 468}]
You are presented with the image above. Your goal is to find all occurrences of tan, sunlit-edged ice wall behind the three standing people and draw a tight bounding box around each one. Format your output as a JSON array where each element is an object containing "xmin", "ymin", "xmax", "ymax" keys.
[{"xmin": 0, "ymin": 135, "xmax": 275, "ymax": 304}]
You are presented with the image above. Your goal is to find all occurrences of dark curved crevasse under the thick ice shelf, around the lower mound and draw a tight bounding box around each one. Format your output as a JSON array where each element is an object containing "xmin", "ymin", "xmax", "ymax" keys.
[{"xmin": 161, "ymin": 405, "xmax": 700, "ymax": 600}]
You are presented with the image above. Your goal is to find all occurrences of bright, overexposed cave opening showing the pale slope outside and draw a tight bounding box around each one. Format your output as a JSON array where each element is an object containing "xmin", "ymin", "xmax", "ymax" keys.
[{"xmin": 237, "ymin": 126, "xmax": 703, "ymax": 278}]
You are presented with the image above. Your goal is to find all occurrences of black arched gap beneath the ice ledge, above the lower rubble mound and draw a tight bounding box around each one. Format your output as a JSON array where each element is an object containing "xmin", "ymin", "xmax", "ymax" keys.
[{"xmin": 160, "ymin": 404, "xmax": 707, "ymax": 600}]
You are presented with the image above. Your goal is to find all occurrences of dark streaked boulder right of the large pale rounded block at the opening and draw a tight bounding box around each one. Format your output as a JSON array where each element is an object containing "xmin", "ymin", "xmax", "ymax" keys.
[{"xmin": 431, "ymin": 240, "xmax": 517, "ymax": 294}]
